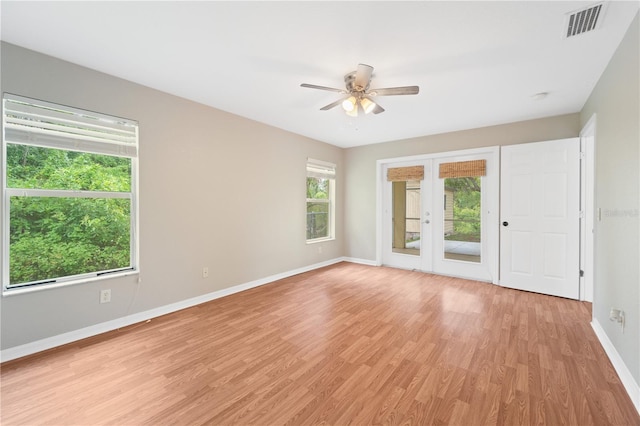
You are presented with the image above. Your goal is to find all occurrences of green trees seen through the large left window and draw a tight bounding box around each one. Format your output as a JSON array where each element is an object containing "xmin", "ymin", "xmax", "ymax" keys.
[{"xmin": 6, "ymin": 143, "xmax": 132, "ymax": 285}]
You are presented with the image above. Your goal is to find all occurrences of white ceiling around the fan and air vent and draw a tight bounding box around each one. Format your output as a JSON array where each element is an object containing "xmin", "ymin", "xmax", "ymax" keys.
[{"xmin": 0, "ymin": 0, "xmax": 640, "ymax": 147}]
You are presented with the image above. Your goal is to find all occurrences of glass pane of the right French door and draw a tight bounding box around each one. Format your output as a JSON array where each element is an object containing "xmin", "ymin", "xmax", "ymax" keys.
[{"xmin": 443, "ymin": 177, "xmax": 482, "ymax": 263}]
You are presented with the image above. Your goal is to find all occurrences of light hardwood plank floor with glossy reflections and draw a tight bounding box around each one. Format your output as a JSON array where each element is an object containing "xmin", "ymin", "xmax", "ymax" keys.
[{"xmin": 0, "ymin": 263, "xmax": 640, "ymax": 426}]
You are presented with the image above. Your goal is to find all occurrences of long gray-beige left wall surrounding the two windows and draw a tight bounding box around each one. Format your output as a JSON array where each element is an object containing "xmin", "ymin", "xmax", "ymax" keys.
[{"xmin": 0, "ymin": 43, "xmax": 344, "ymax": 349}]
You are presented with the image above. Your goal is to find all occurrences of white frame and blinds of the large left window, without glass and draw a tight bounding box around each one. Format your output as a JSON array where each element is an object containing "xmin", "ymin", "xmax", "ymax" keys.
[{"xmin": 0, "ymin": 93, "xmax": 140, "ymax": 296}]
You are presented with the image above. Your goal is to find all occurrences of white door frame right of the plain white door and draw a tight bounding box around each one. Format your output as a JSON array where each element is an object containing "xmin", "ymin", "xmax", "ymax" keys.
[{"xmin": 580, "ymin": 114, "xmax": 596, "ymax": 302}]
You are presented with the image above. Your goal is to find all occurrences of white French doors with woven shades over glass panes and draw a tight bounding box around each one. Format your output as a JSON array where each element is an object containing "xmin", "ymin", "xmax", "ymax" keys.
[{"xmin": 379, "ymin": 148, "xmax": 498, "ymax": 283}]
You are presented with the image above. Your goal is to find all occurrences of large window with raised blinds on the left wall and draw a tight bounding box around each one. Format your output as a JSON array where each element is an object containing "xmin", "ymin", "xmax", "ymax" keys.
[{"xmin": 2, "ymin": 95, "xmax": 138, "ymax": 291}]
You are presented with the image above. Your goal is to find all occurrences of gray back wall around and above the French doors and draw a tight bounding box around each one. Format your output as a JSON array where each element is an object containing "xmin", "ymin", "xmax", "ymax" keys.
[{"xmin": 344, "ymin": 114, "xmax": 580, "ymax": 261}]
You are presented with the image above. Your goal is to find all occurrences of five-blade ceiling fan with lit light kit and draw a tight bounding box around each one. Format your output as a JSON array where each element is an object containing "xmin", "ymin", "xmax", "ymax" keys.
[{"xmin": 300, "ymin": 64, "xmax": 420, "ymax": 117}]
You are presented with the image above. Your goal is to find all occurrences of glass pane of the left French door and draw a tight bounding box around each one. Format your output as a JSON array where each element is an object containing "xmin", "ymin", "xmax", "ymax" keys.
[{"xmin": 392, "ymin": 180, "xmax": 421, "ymax": 256}]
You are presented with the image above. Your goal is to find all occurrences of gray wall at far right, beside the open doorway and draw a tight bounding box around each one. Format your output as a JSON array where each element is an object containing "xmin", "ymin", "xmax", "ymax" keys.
[{"xmin": 580, "ymin": 14, "xmax": 640, "ymax": 383}]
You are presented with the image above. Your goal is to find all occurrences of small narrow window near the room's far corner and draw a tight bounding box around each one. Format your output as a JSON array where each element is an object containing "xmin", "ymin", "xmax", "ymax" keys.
[{"xmin": 307, "ymin": 159, "xmax": 336, "ymax": 242}]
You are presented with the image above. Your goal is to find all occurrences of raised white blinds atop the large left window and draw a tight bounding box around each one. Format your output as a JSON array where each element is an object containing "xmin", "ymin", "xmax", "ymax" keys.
[{"xmin": 3, "ymin": 94, "xmax": 138, "ymax": 158}]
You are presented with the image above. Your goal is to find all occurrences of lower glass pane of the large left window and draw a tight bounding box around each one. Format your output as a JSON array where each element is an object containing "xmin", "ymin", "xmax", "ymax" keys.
[{"xmin": 9, "ymin": 197, "xmax": 131, "ymax": 284}]
